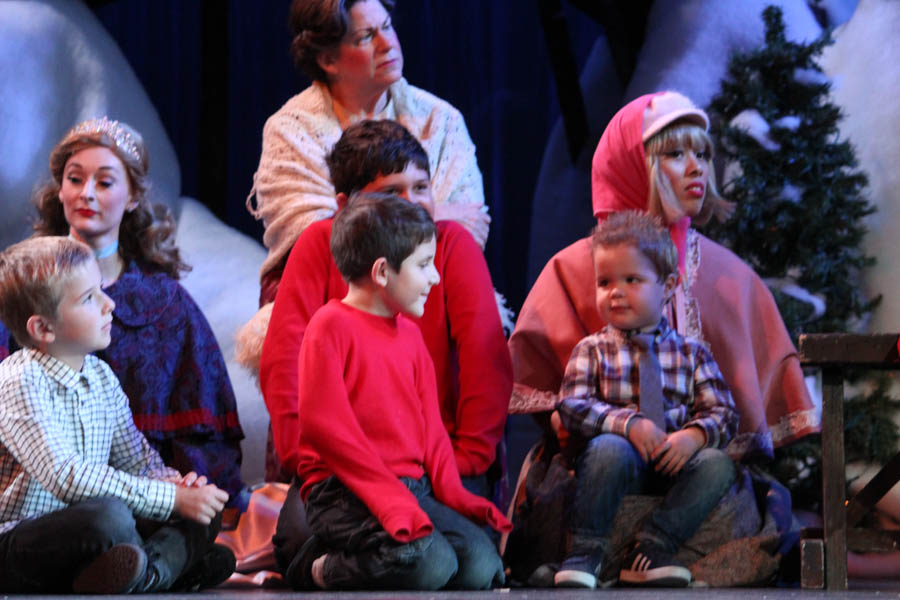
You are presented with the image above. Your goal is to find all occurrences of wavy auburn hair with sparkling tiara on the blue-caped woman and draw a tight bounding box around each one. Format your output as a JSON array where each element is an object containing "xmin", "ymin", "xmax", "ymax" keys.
[{"xmin": 32, "ymin": 117, "xmax": 190, "ymax": 279}]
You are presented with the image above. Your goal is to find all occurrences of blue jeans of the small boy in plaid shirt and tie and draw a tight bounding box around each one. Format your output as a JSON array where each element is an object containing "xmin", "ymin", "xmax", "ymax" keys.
[{"xmin": 570, "ymin": 434, "xmax": 735, "ymax": 554}]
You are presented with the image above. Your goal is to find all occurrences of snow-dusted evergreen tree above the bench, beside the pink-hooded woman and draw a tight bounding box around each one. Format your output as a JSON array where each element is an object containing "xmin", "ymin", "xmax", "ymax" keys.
[{"xmin": 708, "ymin": 6, "xmax": 880, "ymax": 339}]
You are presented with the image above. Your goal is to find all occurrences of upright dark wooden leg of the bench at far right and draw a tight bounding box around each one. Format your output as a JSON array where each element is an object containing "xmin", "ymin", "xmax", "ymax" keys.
[{"xmin": 822, "ymin": 368, "xmax": 847, "ymax": 590}]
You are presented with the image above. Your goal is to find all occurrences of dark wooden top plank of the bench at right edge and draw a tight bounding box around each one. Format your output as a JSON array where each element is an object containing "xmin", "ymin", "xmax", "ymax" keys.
[{"xmin": 799, "ymin": 333, "xmax": 900, "ymax": 369}]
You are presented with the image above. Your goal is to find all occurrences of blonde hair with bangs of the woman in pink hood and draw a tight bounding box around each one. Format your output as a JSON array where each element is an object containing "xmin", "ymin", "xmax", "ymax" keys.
[{"xmin": 644, "ymin": 121, "xmax": 734, "ymax": 225}]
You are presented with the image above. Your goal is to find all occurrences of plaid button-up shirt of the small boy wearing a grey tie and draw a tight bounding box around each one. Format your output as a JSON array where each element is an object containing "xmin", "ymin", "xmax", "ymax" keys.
[{"xmin": 557, "ymin": 318, "xmax": 739, "ymax": 448}]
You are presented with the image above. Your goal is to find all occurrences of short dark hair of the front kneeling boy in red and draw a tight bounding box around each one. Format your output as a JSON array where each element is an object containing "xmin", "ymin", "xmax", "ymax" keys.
[{"xmin": 331, "ymin": 194, "xmax": 435, "ymax": 282}]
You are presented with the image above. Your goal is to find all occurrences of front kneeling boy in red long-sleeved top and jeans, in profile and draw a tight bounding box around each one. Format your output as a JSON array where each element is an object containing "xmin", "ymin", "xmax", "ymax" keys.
[{"xmin": 285, "ymin": 194, "xmax": 511, "ymax": 590}]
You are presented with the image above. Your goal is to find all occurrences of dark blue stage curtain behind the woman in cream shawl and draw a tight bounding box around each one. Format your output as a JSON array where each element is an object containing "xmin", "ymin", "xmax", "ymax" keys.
[{"xmin": 91, "ymin": 0, "xmax": 601, "ymax": 311}]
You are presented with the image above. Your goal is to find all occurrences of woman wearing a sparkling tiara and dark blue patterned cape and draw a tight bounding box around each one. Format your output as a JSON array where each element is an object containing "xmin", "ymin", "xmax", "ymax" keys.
[{"xmin": 0, "ymin": 117, "xmax": 249, "ymax": 509}]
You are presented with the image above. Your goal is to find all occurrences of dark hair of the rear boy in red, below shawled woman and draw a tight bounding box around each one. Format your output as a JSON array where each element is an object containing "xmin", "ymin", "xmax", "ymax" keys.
[{"xmin": 325, "ymin": 120, "xmax": 431, "ymax": 196}]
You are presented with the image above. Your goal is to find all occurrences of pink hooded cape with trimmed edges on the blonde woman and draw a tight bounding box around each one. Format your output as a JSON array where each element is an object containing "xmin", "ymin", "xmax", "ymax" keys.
[{"xmin": 509, "ymin": 95, "xmax": 819, "ymax": 458}]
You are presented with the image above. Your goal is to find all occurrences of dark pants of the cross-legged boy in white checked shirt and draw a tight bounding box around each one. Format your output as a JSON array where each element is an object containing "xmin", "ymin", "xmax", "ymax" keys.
[{"xmin": 0, "ymin": 498, "xmax": 219, "ymax": 593}]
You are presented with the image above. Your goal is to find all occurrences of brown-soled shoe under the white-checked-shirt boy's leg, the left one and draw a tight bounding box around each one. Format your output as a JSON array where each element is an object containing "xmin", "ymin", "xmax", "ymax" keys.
[{"xmin": 72, "ymin": 544, "xmax": 147, "ymax": 594}]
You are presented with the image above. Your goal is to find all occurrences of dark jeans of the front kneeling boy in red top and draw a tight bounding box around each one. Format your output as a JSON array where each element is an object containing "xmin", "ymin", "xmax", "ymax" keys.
[{"xmin": 274, "ymin": 477, "xmax": 503, "ymax": 590}]
